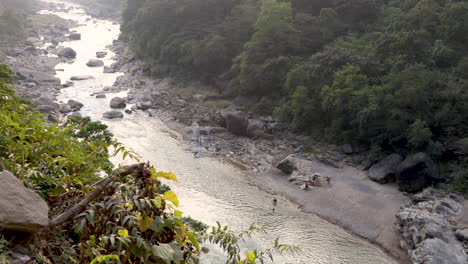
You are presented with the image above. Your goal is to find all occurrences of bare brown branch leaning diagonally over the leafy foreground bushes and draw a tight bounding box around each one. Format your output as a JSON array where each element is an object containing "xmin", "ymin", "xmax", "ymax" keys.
[{"xmin": 47, "ymin": 163, "xmax": 146, "ymax": 229}]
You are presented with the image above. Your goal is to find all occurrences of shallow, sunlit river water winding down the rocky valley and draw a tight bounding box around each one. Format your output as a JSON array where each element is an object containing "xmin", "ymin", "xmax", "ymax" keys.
[{"xmin": 42, "ymin": 0, "xmax": 396, "ymax": 264}]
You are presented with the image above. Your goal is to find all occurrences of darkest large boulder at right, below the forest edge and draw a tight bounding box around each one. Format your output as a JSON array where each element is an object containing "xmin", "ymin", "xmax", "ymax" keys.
[{"xmin": 396, "ymin": 152, "xmax": 442, "ymax": 193}]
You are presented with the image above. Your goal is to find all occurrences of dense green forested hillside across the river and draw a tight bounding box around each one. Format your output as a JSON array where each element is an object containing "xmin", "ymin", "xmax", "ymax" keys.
[{"xmin": 123, "ymin": 0, "xmax": 468, "ymax": 164}]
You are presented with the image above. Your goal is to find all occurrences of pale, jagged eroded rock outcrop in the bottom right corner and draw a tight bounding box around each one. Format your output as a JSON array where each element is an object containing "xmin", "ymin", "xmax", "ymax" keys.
[{"xmin": 397, "ymin": 189, "xmax": 468, "ymax": 264}]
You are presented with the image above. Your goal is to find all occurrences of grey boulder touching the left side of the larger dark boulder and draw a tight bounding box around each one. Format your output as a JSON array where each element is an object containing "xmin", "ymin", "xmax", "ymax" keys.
[{"xmin": 368, "ymin": 154, "xmax": 403, "ymax": 183}]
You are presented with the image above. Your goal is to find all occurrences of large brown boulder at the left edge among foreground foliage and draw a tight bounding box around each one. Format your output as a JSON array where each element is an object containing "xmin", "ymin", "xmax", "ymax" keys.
[{"xmin": 0, "ymin": 171, "xmax": 49, "ymax": 232}]
